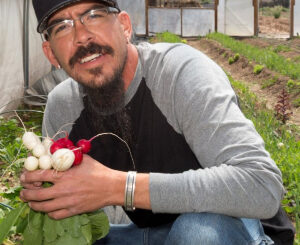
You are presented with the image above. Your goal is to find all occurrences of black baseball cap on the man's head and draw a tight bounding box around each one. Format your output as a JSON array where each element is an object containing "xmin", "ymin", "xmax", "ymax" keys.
[{"xmin": 32, "ymin": 0, "xmax": 121, "ymax": 33}]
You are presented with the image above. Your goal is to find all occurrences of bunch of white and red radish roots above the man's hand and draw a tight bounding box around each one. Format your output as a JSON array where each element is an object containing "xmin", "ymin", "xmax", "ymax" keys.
[{"xmin": 22, "ymin": 132, "xmax": 93, "ymax": 171}]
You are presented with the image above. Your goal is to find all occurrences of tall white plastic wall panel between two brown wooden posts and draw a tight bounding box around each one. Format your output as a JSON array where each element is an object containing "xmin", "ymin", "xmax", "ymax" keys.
[{"xmin": 218, "ymin": 0, "xmax": 254, "ymax": 36}]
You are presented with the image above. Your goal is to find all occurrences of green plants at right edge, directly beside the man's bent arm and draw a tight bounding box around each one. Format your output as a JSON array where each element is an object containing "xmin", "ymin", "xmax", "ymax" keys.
[{"xmin": 229, "ymin": 77, "xmax": 300, "ymax": 245}]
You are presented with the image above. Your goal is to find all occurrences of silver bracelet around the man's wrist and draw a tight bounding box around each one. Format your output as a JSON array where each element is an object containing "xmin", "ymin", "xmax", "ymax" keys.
[{"xmin": 124, "ymin": 171, "xmax": 136, "ymax": 211}]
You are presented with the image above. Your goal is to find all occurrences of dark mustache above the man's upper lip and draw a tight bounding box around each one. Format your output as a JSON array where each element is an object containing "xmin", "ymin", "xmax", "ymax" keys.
[{"xmin": 69, "ymin": 42, "xmax": 114, "ymax": 68}]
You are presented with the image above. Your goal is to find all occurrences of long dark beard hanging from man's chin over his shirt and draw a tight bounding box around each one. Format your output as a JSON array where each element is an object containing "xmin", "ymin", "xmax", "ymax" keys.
[{"xmin": 83, "ymin": 72, "xmax": 132, "ymax": 145}]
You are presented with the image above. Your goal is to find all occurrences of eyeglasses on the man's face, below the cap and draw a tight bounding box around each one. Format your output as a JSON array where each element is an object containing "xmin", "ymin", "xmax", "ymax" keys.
[{"xmin": 43, "ymin": 7, "xmax": 120, "ymax": 40}]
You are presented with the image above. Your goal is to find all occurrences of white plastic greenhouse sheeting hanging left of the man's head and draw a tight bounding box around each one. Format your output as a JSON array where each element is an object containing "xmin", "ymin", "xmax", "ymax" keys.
[{"xmin": 0, "ymin": 0, "xmax": 51, "ymax": 115}]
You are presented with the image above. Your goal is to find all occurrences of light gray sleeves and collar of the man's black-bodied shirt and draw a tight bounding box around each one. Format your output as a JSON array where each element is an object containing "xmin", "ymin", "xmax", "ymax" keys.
[{"xmin": 44, "ymin": 43, "xmax": 283, "ymax": 222}]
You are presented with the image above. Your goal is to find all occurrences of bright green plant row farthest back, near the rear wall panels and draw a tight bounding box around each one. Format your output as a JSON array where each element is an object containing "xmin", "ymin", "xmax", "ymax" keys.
[{"xmin": 207, "ymin": 33, "xmax": 300, "ymax": 79}]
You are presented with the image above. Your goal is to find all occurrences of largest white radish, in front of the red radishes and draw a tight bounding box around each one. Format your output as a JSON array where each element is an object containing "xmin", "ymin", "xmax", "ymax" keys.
[{"xmin": 52, "ymin": 148, "xmax": 75, "ymax": 171}]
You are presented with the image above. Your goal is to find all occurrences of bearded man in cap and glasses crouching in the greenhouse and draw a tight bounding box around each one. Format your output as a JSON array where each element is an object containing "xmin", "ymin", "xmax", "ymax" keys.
[{"xmin": 21, "ymin": 0, "xmax": 283, "ymax": 245}]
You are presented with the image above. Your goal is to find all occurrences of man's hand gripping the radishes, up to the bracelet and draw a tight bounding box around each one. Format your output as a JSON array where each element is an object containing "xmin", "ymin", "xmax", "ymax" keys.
[{"xmin": 20, "ymin": 155, "xmax": 126, "ymax": 219}]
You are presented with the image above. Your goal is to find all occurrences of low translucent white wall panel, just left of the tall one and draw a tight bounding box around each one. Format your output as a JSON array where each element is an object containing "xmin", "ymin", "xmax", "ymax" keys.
[{"xmin": 182, "ymin": 9, "xmax": 215, "ymax": 37}]
